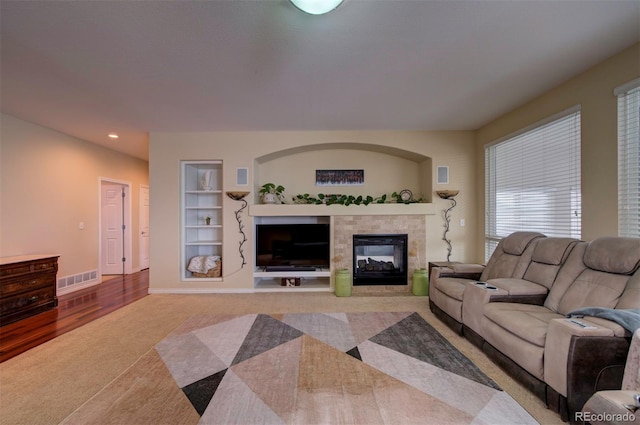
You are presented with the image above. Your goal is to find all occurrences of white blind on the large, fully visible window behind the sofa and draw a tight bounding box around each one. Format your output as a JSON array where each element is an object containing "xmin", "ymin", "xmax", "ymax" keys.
[{"xmin": 485, "ymin": 108, "xmax": 582, "ymax": 260}]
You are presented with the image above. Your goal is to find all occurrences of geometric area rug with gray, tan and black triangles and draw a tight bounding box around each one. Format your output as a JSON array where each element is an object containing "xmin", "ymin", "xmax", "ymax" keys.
[{"xmin": 152, "ymin": 312, "xmax": 537, "ymax": 425}]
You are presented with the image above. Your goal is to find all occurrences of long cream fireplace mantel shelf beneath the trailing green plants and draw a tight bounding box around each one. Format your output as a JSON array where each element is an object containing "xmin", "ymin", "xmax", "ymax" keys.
[{"xmin": 249, "ymin": 203, "xmax": 435, "ymax": 217}]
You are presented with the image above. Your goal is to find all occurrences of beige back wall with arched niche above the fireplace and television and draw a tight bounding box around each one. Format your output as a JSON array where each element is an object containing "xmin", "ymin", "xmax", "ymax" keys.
[{"xmin": 149, "ymin": 132, "xmax": 476, "ymax": 292}]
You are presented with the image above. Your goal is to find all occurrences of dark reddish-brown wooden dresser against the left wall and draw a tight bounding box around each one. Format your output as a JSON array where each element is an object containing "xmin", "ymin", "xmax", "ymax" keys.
[{"xmin": 0, "ymin": 255, "xmax": 58, "ymax": 326}]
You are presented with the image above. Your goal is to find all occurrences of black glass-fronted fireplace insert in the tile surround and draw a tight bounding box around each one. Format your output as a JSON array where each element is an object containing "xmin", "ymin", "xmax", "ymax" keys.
[{"xmin": 353, "ymin": 234, "xmax": 407, "ymax": 286}]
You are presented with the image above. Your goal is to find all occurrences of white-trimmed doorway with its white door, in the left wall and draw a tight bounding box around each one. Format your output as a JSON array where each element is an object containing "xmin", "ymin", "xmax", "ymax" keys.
[{"xmin": 99, "ymin": 178, "xmax": 133, "ymax": 275}]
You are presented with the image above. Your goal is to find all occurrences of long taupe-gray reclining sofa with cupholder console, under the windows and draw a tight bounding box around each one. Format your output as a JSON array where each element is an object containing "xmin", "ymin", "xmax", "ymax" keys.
[{"xmin": 429, "ymin": 232, "xmax": 640, "ymax": 422}]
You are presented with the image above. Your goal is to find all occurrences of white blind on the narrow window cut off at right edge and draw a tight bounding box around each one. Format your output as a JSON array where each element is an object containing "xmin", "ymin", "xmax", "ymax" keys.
[{"xmin": 614, "ymin": 79, "xmax": 640, "ymax": 238}]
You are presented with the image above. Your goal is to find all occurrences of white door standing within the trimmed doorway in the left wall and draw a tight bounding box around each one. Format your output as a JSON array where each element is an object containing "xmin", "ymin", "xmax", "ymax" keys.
[{"xmin": 102, "ymin": 183, "xmax": 124, "ymax": 274}]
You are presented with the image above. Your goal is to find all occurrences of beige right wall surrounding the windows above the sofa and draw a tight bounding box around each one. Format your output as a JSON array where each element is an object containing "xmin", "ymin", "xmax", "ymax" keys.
[{"xmin": 476, "ymin": 44, "xmax": 640, "ymax": 261}]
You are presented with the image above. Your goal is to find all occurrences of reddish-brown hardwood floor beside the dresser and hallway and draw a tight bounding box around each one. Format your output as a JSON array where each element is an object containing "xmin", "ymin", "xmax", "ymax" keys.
[{"xmin": 0, "ymin": 269, "xmax": 149, "ymax": 363}]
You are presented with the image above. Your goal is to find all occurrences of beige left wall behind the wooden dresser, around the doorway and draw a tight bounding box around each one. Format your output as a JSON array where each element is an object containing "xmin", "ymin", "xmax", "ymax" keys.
[{"xmin": 0, "ymin": 115, "xmax": 149, "ymax": 277}]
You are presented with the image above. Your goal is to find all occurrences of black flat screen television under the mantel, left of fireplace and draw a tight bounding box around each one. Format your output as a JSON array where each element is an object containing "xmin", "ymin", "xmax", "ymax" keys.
[{"xmin": 256, "ymin": 223, "xmax": 330, "ymax": 271}]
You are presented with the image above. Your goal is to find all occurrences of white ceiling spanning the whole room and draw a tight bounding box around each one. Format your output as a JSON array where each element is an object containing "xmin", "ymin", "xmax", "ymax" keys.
[{"xmin": 0, "ymin": 0, "xmax": 640, "ymax": 159}]
